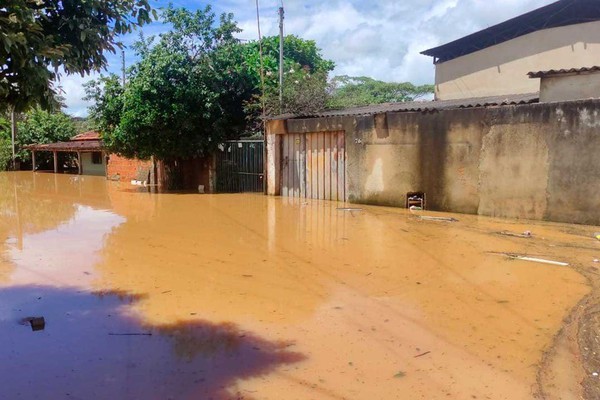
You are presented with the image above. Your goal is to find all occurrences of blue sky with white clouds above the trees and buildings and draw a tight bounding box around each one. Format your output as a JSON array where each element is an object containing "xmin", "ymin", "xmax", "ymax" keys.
[{"xmin": 59, "ymin": 0, "xmax": 553, "ymax": 116}]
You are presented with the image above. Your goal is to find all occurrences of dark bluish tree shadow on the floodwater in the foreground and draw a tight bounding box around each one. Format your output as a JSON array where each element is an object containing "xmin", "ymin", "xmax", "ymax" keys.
[{"xmin": 0, "ymin": 286, "xmax": 305, "ymax": 400}]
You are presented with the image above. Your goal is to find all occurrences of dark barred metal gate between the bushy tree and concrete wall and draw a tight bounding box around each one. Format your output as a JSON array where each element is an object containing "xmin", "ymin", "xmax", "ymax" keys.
[{"xmin": 216, "ymin": 140, "xmax": 264, "ymax": 193}]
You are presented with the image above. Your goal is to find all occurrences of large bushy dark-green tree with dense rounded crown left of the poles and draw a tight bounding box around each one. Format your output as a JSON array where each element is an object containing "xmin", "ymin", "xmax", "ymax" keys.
[{"xmin": 88, "ymin": 7, "xmax": 252, "ymax": 160}]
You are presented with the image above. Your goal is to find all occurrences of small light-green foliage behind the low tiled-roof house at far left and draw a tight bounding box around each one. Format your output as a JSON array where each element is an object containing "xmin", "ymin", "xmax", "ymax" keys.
[{"xmin": 16, "ymin": 108, "xmax": 77, "ymax": 162}]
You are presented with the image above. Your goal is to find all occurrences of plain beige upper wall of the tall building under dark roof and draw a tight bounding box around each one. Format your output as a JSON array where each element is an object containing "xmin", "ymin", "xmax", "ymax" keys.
[{"xmin": 435, "ymin": 21, "xmax": 600, "ymax": 100}]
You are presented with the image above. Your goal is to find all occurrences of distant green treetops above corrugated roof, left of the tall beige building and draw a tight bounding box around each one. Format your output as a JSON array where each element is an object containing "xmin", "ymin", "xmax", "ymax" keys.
[{"xmin": 327, "ymin": 76, "xmax": 434, "ymax": 109}]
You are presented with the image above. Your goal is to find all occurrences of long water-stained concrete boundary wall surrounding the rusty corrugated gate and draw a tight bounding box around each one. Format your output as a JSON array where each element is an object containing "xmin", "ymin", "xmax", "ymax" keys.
[{"xmin": 268, "ymin": 100, "xmax": 600, "ymax": 225}]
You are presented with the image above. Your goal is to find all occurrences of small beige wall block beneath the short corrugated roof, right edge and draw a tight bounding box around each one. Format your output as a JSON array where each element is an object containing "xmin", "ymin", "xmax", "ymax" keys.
[{"xmin": 540, "ymin": 72, "xmax": 600, "ymax": 102}]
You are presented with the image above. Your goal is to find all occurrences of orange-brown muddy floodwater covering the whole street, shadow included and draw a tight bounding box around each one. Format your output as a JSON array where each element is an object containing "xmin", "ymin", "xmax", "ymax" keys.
[{"xmin": 0, "ymin": 172, "xmax": 600, "ymax": 400}]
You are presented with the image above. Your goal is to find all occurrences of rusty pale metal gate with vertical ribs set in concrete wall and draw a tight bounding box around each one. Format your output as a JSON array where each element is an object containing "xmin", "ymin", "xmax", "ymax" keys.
[{"xmin": 281, "ymin": 131, "xmax": 346, "ymax": 201}]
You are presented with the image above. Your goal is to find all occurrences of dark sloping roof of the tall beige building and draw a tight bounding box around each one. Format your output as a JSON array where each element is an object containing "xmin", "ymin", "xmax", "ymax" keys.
[{"xmin": 421, "ymin": 0, "xmax": 600, "ymax": 63}]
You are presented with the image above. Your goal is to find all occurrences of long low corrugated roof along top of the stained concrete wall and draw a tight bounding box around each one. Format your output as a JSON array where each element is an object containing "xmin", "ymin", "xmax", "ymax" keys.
[{"xmin": 272, "ymin": 93, "xmax": 539, "ymax": 119}]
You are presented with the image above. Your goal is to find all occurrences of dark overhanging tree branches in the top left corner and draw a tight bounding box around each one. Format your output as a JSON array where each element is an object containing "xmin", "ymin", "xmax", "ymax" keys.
[{"xmin": 0, "ymin": 0, "xmax": 153, "ymax": 112}]
